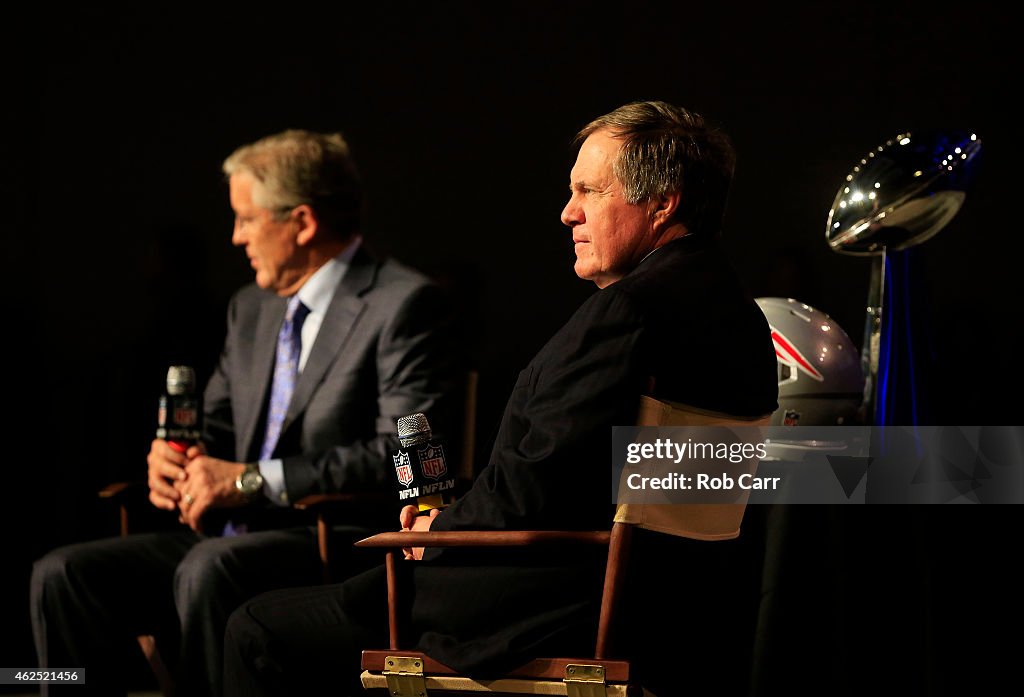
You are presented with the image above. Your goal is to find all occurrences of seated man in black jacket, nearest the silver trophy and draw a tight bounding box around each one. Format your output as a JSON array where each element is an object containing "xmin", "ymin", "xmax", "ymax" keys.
[{"xmin": 225, "ymin": 102, "xmax": 776, "ymax": 697}]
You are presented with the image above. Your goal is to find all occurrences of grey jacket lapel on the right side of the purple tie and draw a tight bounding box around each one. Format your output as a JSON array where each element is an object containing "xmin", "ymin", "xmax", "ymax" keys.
[{"xmin": 282, "ymin": 247, "xmax": 378, "ymax": 434}]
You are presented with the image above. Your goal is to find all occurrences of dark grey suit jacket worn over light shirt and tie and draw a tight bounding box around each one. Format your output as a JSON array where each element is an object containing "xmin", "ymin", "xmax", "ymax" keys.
[{"xmin": 204, "ymin": 247, "xmax": 458, "ymax": 528}]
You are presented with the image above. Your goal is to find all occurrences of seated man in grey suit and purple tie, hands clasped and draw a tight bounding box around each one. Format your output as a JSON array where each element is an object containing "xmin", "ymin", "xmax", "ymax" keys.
[{"xmin": 32, "ymin": 131, "xmax": 455, "ymax": 696}]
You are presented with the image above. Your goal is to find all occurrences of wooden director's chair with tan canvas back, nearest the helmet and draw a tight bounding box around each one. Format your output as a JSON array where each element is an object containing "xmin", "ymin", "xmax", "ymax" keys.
[{"xmin": 356, "ymin": 396, "xmax": 769, "ymax": 697}]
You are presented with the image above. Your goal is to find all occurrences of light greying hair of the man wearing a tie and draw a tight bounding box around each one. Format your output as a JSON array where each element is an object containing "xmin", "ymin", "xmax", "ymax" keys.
[{"xmin": 222, "ymin": 130, "xmax": 362, "ymax": 237}]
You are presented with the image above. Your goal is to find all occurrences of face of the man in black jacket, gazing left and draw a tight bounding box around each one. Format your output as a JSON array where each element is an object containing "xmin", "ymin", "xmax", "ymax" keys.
[{"xmin": 561, "ymin": 130, "xmax": 654, "ymax": 288}]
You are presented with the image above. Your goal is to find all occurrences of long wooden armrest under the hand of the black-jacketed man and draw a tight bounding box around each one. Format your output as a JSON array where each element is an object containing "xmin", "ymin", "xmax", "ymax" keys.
[{"xmin": 355, "ymin": 530, "xmax": 611, "ymax": 549}]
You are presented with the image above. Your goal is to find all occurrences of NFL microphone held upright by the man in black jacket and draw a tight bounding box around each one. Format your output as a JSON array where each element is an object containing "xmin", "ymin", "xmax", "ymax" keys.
[{"xmin": 391, "ymin": 413, "xmax": 455, "ymax": 512}]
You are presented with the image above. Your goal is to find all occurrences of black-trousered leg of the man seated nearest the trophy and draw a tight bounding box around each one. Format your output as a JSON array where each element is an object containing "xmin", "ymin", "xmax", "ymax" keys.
[{"xmin": 224, "ymin": 566, "xmax": 387, "ymax": 697}]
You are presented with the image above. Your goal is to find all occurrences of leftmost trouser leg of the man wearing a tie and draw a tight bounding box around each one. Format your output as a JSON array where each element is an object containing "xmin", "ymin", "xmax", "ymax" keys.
[{"xmin": 31, "ymin": 530, "xmax": 199, "ymax": 694}]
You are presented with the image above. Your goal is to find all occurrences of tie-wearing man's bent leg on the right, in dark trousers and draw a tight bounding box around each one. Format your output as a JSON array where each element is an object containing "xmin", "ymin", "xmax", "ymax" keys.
[{"xmin": 174, "ymin": 528, "xmax": 322, "ymax": 697}]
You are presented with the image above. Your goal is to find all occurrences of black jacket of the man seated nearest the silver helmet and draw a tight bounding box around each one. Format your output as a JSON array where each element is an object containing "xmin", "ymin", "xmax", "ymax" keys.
[{"xmin": 412, "ymin": 236, "xmax": 777, "ymax": 672}]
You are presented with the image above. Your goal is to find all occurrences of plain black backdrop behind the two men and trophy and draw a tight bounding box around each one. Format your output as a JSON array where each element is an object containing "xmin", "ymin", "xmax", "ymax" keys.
[{"xmin": 0, "ymin": 2, "xmax": 1022, "ymax": 690}]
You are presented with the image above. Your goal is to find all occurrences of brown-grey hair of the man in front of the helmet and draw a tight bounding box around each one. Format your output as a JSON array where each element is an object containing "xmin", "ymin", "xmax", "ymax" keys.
[{"xmin": 573, "ymin": 101, "xmax": 736, "ymax": 235}]
